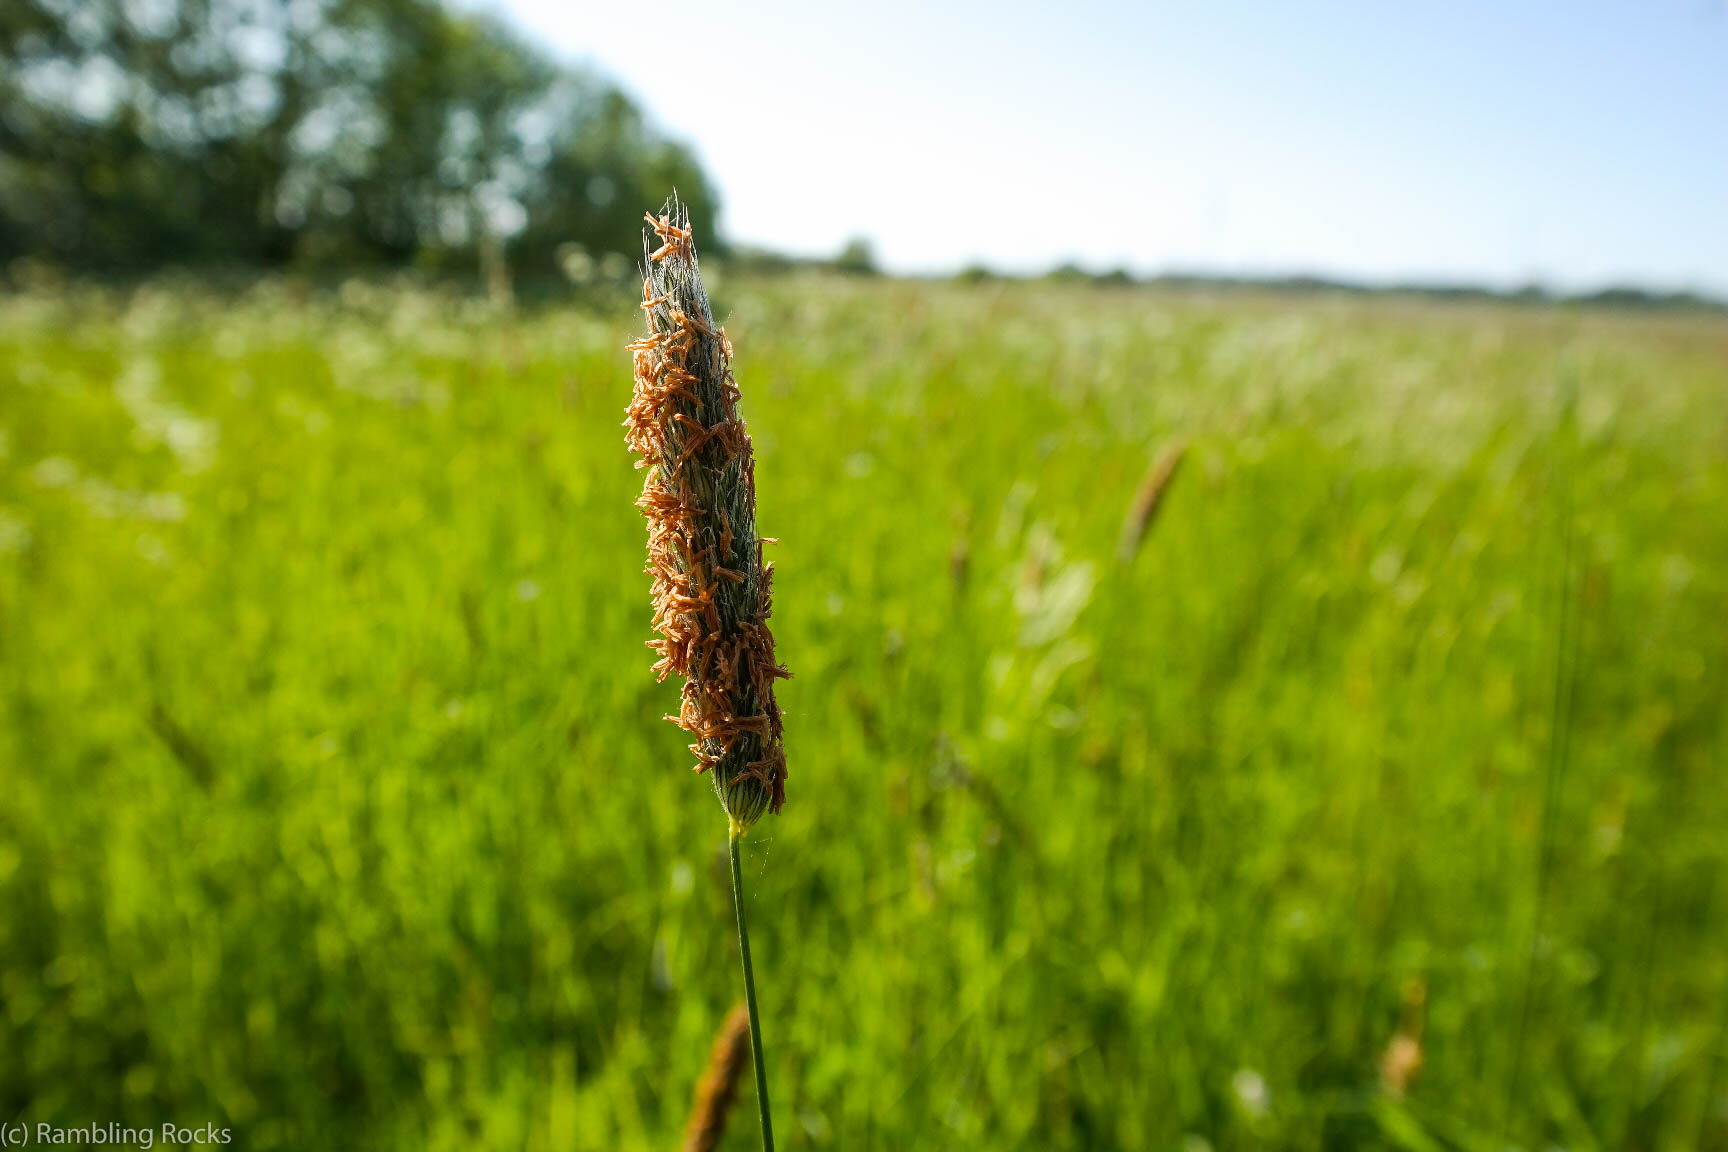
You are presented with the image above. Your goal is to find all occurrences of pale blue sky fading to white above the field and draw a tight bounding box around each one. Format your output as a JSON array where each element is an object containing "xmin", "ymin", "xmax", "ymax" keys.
[{"xmin": 486, "ymin": 0, "xmax": 1728, "ymax": 294}]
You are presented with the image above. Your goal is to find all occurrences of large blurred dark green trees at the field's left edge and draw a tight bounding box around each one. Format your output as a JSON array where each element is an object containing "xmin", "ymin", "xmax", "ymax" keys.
[{"xmin": 0, "ymin": 0, "xmax": 714, "ymax": 271}]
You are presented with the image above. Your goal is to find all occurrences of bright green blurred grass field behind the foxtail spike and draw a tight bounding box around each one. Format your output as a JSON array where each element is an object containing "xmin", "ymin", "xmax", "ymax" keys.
[{"xmin": 0, "ymin": 276, "xmax": 1728, "ymax": 1152}]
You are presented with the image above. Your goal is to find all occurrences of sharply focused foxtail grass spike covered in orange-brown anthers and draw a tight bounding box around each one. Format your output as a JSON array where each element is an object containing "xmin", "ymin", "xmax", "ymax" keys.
[{"xmin": 624, "ymin": 193, "xmax": 788, "ymax": 832}]
